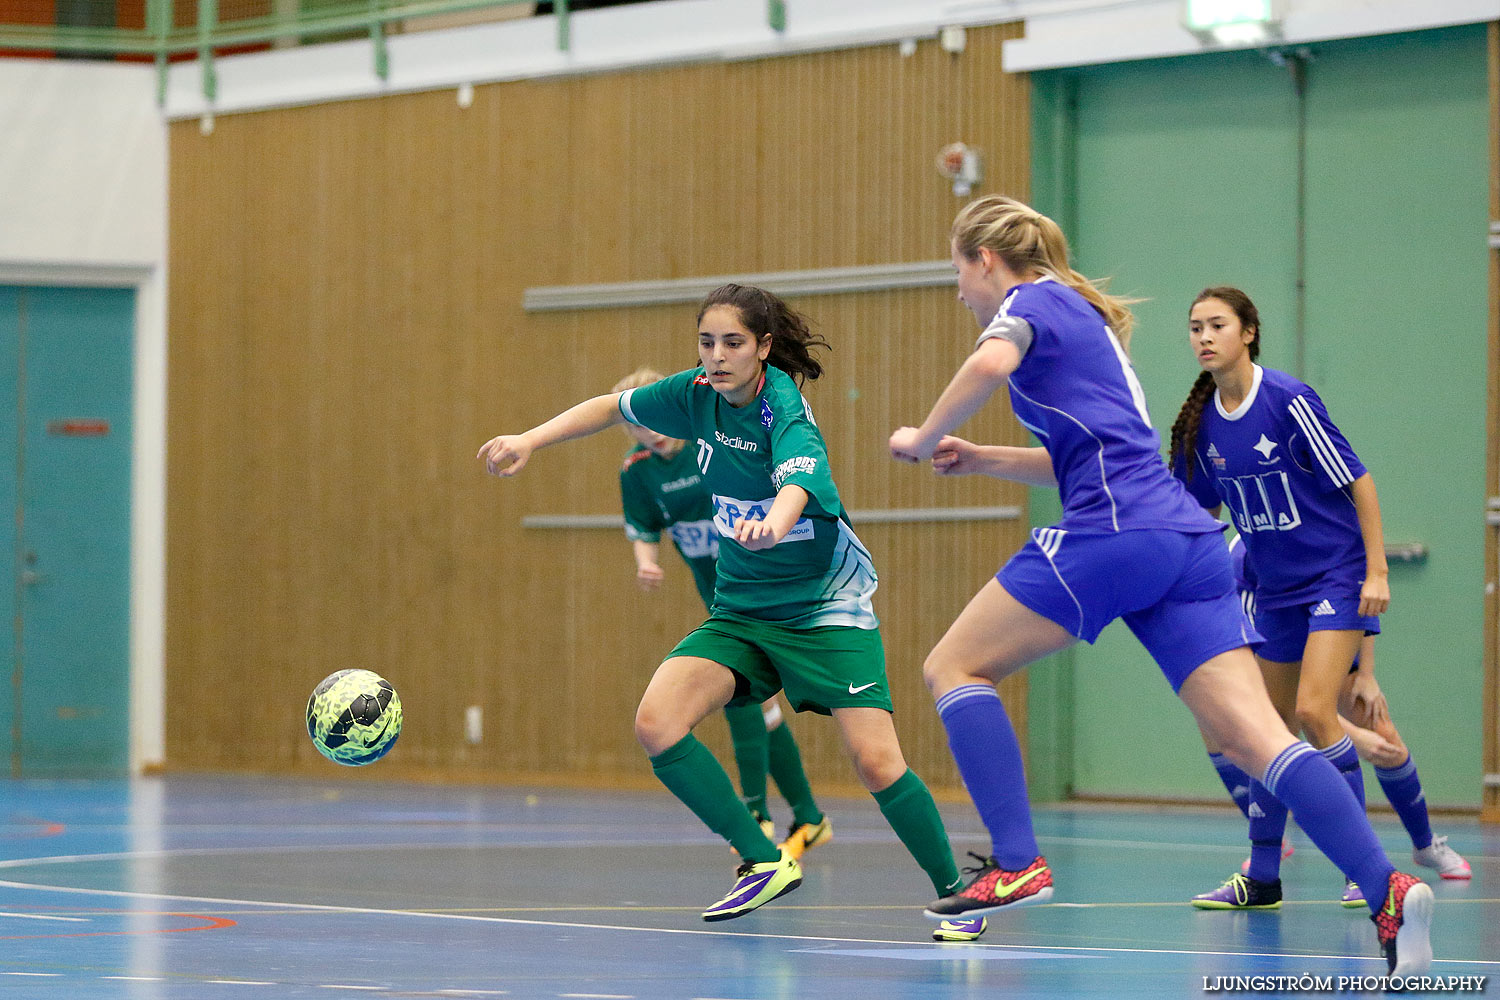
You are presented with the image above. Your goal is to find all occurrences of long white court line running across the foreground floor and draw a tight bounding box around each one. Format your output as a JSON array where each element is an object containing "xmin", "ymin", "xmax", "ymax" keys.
[{"xmin": 0, "ymin": 880, "xmax": 1500, "ymax": 971}]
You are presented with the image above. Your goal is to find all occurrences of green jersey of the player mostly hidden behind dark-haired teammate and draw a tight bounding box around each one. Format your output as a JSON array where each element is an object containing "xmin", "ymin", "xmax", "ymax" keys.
[{"xmin": 620, "ymin": 445, "xmax": 719, "ymax": 609}]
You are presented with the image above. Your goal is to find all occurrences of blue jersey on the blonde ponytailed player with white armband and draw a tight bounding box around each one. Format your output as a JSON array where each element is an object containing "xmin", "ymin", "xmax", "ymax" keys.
[{"xmin": 981, "ymin": 277, "xmax": 1223, "ymax": 534}]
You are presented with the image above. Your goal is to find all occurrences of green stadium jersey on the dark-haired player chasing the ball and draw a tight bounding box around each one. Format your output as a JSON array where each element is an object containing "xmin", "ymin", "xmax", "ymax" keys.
[{"xmin": 620, "ymin": 366, "xmax": 879, "ymax": 628}]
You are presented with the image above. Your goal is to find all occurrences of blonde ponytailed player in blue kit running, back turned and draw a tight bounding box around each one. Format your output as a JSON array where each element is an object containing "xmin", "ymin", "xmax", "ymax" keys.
[{"xmin": 890, "ymin": 195, "xmax": 1434, "ymax": 975}]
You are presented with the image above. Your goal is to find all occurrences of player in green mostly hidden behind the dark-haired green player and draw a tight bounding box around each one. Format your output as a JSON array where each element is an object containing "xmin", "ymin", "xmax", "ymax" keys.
[{"xmin": 611, "ymin": 367, "xmax": 834, "ymax": 859}]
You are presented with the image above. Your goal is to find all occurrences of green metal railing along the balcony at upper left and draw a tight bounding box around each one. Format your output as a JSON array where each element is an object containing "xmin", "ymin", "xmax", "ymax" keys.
[{"xmin": 0, "ymin": 0, "xmax": 570, "ymax": 103}]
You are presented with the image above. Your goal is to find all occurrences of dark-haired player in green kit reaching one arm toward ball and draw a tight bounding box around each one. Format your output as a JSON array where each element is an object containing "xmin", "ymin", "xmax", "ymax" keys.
[{"xmin": 479, "ymin": 285, "xmax": 984, "ymax": 940}]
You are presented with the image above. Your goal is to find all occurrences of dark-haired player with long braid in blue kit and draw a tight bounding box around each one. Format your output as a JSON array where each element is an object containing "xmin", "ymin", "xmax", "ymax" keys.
[{"xmin": 1170, "ymin": 286, "xmax": 1469, "ymax": 910}]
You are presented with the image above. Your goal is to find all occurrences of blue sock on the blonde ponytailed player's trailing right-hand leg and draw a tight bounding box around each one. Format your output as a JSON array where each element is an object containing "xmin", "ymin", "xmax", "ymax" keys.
[{"xmin": 1263, "ymin": 739, "xmax": 1395, "ymax": 913}]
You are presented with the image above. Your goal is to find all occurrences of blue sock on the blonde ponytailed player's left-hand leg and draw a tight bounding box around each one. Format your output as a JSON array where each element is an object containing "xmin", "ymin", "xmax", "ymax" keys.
[{"xmin": 938, "ymin": 684, "xmax": 1041, "ymax": 871}]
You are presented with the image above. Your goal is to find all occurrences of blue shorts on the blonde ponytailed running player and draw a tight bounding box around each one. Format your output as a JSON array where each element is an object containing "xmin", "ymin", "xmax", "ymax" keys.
[{"xmin": 995, "ymin": 528, "xmax": 1259, "ymax": 691}]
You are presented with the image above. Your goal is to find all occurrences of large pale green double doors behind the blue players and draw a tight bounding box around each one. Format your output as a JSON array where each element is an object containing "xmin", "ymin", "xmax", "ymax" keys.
[{"xmin": 1031, "ymin": 25, "xmax": 1488, "ymax": 807}]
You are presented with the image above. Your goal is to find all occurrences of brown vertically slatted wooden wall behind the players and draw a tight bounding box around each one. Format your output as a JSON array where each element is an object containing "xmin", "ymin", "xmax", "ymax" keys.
[{"xmin": 167, "ymin": 27, "xmax": 1029, "ymax": 790}]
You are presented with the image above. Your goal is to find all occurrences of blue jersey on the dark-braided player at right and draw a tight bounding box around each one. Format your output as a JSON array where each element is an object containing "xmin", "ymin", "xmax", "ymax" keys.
[{"xmin": 1173, "ymin": 364, "xmax": 1365, "ymax": 609}]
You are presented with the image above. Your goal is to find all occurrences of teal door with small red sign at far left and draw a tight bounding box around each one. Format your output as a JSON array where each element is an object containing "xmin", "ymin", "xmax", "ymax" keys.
[{"xmin": 0, "ymin": 286, "xmax": 135, "ymax": 777}]
